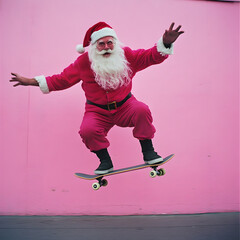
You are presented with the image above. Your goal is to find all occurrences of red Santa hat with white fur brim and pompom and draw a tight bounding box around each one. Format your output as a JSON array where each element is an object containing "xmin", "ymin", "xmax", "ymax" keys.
[{"xmin": 76, "ymin": 22, "xmax": 117, "ymax": 53}]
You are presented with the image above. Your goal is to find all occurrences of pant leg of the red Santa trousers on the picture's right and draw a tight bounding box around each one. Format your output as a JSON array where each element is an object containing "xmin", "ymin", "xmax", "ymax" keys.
[{"xmin": 115, "ymin": 96, "xmax": 156, "ymax": 140}]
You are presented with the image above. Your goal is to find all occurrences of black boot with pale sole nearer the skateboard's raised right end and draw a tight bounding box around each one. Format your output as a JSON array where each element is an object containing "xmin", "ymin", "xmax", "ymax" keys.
[{"xmin": 139, "ymin": 139, "xmax": 163, "ymax": 164}]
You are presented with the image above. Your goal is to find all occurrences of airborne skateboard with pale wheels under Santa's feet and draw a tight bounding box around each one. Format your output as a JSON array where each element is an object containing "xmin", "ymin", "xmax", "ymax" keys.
[{"xmin": 75, "ymin": 154, "xmax": 174, "ymax": 190}]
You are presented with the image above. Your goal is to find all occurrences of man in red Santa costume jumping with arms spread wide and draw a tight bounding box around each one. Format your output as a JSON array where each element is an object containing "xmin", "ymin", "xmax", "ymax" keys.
[{"xmin": 10, "ymin": 22, "xmax": 183, "ymax": 174}]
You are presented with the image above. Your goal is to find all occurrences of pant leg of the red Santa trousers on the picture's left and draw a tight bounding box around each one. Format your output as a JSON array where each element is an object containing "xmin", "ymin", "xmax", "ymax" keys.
[{"xmin": 79, "ymin": 104, "xmax": 114, "ymax": 151}]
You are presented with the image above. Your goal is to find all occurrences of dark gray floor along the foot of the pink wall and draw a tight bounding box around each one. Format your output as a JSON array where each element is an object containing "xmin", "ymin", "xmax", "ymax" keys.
[{"xmin": 0, "ymin": 213, "xmax": 239, "ymax": 240}]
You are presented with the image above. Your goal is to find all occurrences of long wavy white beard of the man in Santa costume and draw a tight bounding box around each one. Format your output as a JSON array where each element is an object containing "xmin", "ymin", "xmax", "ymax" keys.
[{"xmin": 88, "ymin": 40, "xmax": 131, "ymax": 90}]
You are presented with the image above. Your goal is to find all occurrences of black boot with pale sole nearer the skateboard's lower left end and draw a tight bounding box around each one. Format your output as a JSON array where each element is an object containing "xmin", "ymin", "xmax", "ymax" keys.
[{"xmin": 94, "ymin": 148, "xmax": 113, "ymax": 174}]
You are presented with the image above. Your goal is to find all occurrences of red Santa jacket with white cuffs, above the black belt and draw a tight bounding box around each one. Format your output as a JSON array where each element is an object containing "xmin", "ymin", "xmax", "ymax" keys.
[{"xmin": 36, "ymin": 39, "xmax": 172, "ymax": 104}]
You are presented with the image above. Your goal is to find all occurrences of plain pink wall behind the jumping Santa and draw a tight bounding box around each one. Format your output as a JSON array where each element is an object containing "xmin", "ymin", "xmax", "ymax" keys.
[{"xmin": 0, "ymin": 0, "xmax": 239, "ymax": 215}]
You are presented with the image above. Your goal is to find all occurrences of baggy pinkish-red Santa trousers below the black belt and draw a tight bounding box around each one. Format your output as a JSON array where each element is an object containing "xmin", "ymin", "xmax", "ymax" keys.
[{"xmin": 79, "ymin": 96, "xmax": 156, "ymax": 151}]
